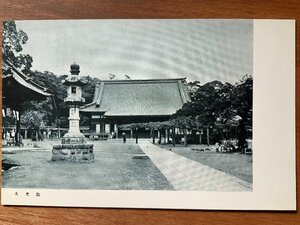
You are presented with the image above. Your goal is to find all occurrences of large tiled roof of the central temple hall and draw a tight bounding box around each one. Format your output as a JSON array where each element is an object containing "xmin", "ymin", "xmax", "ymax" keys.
[{"xmin": 80, "ymin": 78, "xmax": 190, "ymax": 116}]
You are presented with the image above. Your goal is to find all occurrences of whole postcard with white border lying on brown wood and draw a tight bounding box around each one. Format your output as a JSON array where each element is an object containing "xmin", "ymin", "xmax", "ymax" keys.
[{"xmin": 1, "ymin": 19, "xmax": 296, "ymax": 210}]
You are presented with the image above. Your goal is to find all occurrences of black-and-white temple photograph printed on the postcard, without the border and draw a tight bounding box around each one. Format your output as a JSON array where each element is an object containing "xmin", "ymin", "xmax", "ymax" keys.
[{"xmin": 2, "ymin": 19, "xmax": 255, "ymax": 192}]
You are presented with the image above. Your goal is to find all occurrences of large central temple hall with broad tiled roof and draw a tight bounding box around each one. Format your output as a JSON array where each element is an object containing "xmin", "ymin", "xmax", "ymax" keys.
[{"xmin": 80, "ymin": 78, "xmax": 191, "ymax": 138}]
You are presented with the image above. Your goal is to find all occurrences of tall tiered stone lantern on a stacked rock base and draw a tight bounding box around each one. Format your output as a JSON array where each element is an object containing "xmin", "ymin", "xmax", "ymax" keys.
[{"xmin": 52, "ymin": 63, "xmax": 94, "ymax": 162}]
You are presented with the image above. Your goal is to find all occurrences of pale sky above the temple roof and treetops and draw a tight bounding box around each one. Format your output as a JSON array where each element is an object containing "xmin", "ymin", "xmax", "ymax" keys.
[{"xmin": 16, "ymin": 19, "xmax": 253, "ymax": 83}]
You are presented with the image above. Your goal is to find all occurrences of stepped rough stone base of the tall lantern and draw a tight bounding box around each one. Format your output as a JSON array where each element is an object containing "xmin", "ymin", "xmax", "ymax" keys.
[{"xmin": 51, "ymin": 137, "xmax": 94, "ymax": 163}]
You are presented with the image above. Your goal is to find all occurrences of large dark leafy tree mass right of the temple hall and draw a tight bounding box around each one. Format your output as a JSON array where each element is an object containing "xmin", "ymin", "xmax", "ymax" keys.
[{"xmin": 172, "ymin": 75, "xmax": 253, "ymax": 151}]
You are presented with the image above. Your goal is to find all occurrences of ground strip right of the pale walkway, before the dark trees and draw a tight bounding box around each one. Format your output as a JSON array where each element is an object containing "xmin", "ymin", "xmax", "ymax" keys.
[{"xmin": 160, "ymin": 145, "xmax": 253, "ymax": 183}]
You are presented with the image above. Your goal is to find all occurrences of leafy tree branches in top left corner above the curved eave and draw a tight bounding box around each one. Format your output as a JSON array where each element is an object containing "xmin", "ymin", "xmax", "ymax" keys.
[{"xmin": 2, "ymin": 20, "xmax": 33, "ymax": 73}]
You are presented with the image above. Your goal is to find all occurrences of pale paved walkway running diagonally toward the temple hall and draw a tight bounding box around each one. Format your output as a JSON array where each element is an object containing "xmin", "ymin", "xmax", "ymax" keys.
[{"xmin": 139, "ymin": 141, "xmax": 252, "ymax": 192}]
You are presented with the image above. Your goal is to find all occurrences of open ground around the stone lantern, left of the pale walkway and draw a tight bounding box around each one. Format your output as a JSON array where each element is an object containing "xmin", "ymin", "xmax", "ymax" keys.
[{"xmin": 2, "ymin": 141, "xmax": 173, "ymax": 190}]
